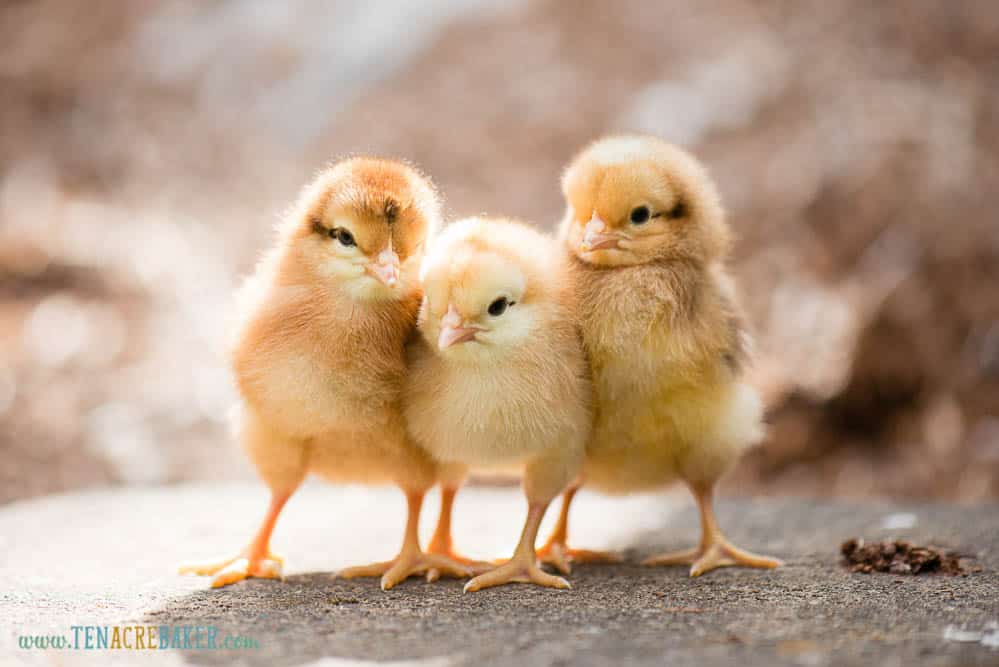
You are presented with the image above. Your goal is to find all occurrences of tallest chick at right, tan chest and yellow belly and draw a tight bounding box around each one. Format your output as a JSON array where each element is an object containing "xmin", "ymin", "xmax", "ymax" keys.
[{"xmin": 549, "ymin": 136, "xmax": 780, "ymax": 576}]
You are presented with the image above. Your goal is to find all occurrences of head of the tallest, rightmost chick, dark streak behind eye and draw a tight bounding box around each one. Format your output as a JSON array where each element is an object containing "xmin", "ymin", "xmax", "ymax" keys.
[{"xmin": 561, "ymin": 136, "xmax": 729, "ymax": 266}]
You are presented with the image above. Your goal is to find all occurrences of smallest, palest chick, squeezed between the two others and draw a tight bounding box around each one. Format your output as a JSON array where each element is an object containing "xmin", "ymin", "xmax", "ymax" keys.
[{"xmin": 403, "ymin": 218, "xmax": 591, "ymax": 591}]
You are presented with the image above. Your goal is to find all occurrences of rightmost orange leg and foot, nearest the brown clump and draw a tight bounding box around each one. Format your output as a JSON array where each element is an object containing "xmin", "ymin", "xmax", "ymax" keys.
[{"xmin": 642, "ymin": 484, "xmax": 783, "ymax": 577}]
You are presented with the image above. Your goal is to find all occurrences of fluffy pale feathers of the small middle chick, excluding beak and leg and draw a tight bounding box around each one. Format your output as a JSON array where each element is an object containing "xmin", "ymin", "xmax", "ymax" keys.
[{"xmin": 405, "ymin": 218, "xmax": 588, "ymax": 466}]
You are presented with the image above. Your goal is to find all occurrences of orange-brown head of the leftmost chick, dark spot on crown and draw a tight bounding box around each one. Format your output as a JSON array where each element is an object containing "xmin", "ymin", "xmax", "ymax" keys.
[{"xmin": 290, "ymin": 157, "xmax": 440, "ymax": 299}]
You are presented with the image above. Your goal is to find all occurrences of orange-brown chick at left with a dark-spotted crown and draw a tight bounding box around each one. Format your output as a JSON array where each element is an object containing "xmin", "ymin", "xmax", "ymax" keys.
[{"xmin": 181, "ymin": 158, "xmax": 470, "ymax": 589}]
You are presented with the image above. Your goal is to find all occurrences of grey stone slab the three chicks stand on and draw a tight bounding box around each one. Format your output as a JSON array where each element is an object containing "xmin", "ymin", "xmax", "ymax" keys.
[{"xmin": 0, "ymin": 484, "xmax": 999, "ymax": 667}]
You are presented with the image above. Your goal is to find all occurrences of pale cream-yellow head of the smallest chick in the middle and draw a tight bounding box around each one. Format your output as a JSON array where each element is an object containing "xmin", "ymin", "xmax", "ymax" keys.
[{"xmin": 419, "ymin": 218, "xmax": 561, "ymax": 363}]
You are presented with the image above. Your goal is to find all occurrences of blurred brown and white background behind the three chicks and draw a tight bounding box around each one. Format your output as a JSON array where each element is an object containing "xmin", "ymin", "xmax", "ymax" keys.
[{"xmin": 0, "ymin": 0, "xmax": 999, "ymax": 502}]
